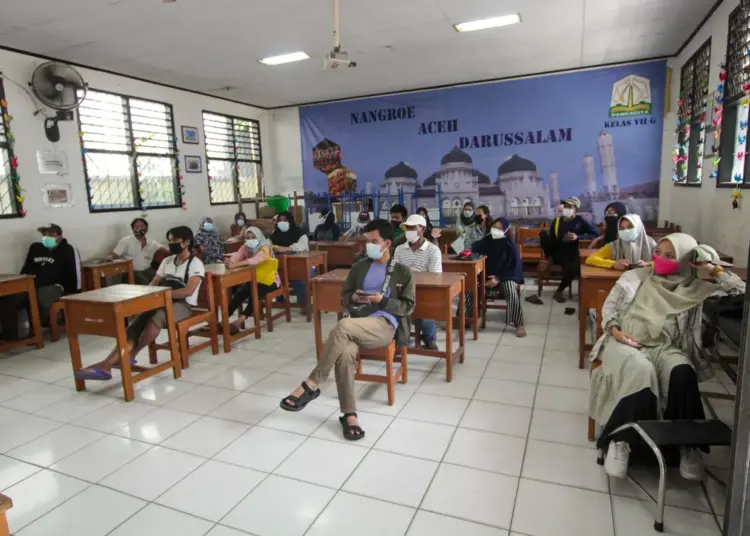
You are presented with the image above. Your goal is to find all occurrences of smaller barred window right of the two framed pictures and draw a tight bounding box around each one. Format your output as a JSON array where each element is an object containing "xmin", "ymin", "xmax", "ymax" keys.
[{"xmin": 203, "ymin": 111, "xmax": 263, "ymax": 205}]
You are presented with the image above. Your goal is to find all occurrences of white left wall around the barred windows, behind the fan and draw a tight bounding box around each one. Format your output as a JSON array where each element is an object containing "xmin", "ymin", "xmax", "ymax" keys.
[{"xmin": 0, "ymin": 50, "xmax": 270, "ymax": 273}]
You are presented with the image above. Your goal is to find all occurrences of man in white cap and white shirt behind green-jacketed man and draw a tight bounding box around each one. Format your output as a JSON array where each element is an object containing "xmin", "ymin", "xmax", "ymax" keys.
[{"xmin": 393, "ymin": 214, "xmax": 443, "ymax": 350}]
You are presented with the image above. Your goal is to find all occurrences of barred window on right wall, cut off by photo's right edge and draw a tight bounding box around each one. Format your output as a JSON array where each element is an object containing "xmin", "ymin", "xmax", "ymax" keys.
[{"xmin": 717, "ymin": 7, "xmax": 750, "ymax": 186}]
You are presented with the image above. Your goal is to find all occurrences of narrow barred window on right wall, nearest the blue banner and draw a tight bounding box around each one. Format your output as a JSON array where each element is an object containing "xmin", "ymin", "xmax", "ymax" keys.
[{"xmin": 677, "ymin": 38, "xmax": 711, "ymax": 184}]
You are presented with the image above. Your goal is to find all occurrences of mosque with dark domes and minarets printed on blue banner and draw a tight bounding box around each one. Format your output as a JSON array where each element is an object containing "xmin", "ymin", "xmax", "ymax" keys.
[{"xmin": 374, "ymin": 130, "xmax": 659, "ymax": 222}]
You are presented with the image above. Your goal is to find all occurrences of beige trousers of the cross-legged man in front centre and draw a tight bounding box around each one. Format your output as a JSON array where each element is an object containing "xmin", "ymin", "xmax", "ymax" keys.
[{"xmin": 310, "ymin": 316, "xmax": 396, "ymax": 413}]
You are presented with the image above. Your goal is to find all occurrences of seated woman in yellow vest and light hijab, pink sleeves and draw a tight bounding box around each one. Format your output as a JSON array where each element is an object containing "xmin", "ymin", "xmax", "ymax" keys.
[{"xmin": 225, "ymin": 227, "xmax": 281, "ymax": 335}]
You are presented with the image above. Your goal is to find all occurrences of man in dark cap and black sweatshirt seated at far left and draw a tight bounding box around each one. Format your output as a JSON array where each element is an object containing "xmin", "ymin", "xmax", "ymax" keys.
[{"xmin": 0, "ymin": 223, "xmax": 81, "ymax": 340}]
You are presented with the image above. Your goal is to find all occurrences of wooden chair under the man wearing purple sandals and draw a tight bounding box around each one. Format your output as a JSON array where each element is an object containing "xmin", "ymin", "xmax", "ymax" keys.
[{"xmin": 148, "ymin": 272, "xmax": 219, "ymax": 368}]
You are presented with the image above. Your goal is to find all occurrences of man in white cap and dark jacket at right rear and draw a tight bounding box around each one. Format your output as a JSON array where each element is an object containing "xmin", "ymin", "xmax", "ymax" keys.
[{"xmin": 539, "ymin": 197, "xmax": 599, "ymax": 303}]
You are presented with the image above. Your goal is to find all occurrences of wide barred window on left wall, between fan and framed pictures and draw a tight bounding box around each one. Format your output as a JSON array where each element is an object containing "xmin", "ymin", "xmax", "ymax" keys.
[{"xmin": 78, "ymin": 90, "xmax": 182, "ymax": 212}]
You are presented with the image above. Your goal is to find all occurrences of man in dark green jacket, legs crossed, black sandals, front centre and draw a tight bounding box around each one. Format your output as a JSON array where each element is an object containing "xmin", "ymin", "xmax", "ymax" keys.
[{"xmin": 281, "ymin": 220, "xmax": 415, "ymax": 440}]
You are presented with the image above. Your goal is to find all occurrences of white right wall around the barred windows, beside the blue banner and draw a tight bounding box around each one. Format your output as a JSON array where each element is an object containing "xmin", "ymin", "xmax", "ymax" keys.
[{"xmin": 659, "ymin": 0, "xmax": 750, "ymax": 266}]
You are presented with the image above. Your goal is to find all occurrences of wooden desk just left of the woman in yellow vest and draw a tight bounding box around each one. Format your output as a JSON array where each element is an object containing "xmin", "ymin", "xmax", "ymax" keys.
[{"xmin": 207, "ymin": 262, "xmax": 262, "ymax": 354}]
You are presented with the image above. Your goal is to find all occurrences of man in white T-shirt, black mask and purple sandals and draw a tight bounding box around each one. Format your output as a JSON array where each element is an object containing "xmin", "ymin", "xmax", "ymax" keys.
[{"xmin": 75, "ymin": 225, "xmax": 206, "ymax": 381}]
